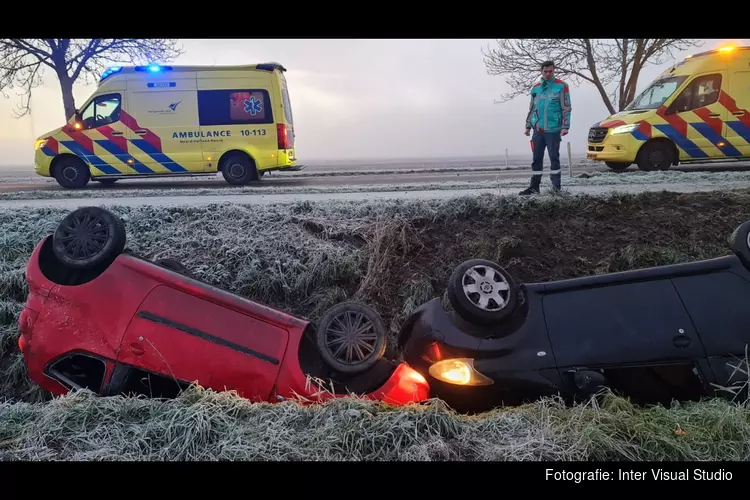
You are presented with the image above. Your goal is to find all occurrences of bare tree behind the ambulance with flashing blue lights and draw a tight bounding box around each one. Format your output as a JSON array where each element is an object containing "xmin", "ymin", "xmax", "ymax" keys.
[{"xmin": 0, "ymin": 38, "xmax": 183, "ymax": 120}]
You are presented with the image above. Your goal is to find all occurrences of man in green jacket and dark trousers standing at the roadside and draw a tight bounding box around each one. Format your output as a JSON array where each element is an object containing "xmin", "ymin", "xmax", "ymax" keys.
[{"xmin": 519, "ymin": 61, "xmax": 573, "ymax": 195}]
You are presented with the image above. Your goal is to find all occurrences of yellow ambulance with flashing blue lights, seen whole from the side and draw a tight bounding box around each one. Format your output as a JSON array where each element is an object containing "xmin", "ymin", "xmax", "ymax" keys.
[{"xmin": 34, "ymin": 63, "xmax": 301, "ymax": 188}]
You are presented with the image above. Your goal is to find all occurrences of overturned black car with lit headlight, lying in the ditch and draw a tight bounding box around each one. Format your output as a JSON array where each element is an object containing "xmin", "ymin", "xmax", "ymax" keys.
[{"xmin": 399, "ymin": 221, "xmax": 750, "ymax": 412}]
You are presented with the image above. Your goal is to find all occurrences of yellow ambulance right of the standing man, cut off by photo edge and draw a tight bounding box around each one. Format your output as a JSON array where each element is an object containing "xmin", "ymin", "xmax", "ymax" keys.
[{"xmin": 587, "ymin": 46, "xmax": 750, "ymax": 171}]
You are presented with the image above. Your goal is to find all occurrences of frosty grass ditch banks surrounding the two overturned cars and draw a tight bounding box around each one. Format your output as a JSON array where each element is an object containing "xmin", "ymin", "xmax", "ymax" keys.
[{"xmin": 0, "ymin": 190, "xmax": 750, "ymax": 460}]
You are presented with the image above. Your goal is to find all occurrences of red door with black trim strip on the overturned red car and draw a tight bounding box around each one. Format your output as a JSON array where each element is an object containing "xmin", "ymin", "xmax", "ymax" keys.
[{"xmin": 117, "ymin": 285, "xmax": 288, "ymax": 401}]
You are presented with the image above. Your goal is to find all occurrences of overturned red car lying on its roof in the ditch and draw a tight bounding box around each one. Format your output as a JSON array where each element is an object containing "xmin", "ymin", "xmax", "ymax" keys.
[{"xmin": 18, "ymin": 207, "xmax": 430, "ymax": 405}]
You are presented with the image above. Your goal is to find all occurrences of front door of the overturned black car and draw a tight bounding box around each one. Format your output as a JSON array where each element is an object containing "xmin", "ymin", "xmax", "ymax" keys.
[{"xmin": 543, "ymin": 279, "xmax": 710, "ymax": 403}]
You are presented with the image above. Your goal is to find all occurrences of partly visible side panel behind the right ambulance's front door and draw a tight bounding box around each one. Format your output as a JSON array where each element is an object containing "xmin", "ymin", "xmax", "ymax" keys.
[{"xmin": 721, "ymin": 68, "xmax": 750, "ymax": 156}]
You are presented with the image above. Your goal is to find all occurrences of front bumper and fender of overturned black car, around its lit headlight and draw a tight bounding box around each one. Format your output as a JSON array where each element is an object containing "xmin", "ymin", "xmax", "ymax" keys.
[{"xmin": 399, "ymin": 299, "xmax": 561, "ymax": 412}]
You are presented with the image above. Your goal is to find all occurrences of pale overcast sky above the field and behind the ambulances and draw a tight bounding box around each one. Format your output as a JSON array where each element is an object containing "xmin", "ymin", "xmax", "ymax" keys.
[{"xmin": 0, "ymin": 39, "xmax": 750, "ymax": 166}]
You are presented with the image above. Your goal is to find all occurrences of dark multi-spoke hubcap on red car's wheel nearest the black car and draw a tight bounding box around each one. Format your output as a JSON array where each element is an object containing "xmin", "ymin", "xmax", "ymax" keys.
[{"xmin": 326, "ymin": 312, "xmax": 378, "ymax": 364}]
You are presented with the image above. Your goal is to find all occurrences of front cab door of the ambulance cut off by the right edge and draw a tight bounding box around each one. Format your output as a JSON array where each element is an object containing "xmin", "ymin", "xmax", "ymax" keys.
[{"xmin": 655, "ymin": 71, "xmax": 740, "ymax": 159}]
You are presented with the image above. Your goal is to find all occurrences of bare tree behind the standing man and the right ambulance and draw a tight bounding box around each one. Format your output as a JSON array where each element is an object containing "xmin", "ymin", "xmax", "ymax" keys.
[{"xmin": 482, "ymin": 38, "xmax": 703, "ymax": 114}]
